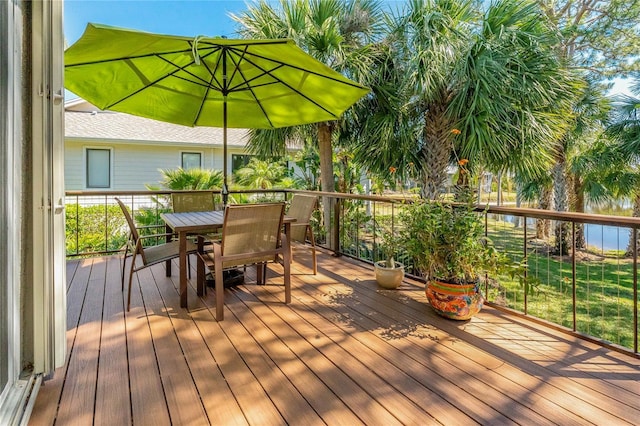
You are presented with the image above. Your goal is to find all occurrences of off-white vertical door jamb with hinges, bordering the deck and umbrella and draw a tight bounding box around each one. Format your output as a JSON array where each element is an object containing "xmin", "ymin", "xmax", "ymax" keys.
[{"xmin": 31, "ymin": 0, "xmax": 66, "ymax": 375}]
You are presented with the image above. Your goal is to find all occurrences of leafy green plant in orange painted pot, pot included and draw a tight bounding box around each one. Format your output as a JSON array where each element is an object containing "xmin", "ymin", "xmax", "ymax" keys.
[{"xmin": 401, "ymin": 187, "xmax": 511, "ymax": 320}]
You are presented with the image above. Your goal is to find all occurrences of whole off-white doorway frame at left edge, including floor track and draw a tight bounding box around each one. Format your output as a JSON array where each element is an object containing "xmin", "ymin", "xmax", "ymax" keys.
[{"xmin": 0, "ymin": 0, "xmax": 66, "ymax": 425}]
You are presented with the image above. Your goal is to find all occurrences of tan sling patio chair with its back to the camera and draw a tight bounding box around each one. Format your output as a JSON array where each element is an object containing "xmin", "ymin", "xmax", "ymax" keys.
[{"xmin": 198, "ymin": 203, "xmax": 291, "ymax": 321}]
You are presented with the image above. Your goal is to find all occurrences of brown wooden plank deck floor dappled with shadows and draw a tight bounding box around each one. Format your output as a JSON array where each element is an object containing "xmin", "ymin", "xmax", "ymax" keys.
[{"xmin": 31, "ymin": 249, "xmax": 640, "ymax": 426}]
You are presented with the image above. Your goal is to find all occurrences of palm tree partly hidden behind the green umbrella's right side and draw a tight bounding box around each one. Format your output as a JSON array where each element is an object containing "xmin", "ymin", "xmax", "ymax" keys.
[{"xmin": 231, "ymin": 0, "xmax": 382, "ymax": 192}]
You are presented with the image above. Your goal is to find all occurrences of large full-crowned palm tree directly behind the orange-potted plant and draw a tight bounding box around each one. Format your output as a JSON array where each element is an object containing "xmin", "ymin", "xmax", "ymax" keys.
[{"xmin": 350, "ymin": 0, "xmax": 575, "ymax": 199}]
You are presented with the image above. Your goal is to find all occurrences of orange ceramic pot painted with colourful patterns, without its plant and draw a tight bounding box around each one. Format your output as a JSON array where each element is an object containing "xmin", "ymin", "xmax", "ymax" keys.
[{"xmin": 426, "ymin": 280, "xmax": 484, "ymax": 320}]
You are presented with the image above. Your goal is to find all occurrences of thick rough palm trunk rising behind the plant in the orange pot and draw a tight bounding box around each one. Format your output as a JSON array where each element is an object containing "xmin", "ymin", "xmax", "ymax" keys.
[{"xmin": 420, "ymin": 100, "xmax": 453, "ymax": 200}]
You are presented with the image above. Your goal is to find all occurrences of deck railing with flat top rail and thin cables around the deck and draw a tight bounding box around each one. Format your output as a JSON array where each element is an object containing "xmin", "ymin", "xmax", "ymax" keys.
[{"xmin": 66, "ymin": 190, "xmax": 640, "ymax": 356}]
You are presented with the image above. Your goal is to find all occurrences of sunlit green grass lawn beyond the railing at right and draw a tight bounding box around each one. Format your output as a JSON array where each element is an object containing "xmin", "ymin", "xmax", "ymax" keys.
[{"xmin": 487, "ymin": 216, "xmax": 634, "ymax": 348}]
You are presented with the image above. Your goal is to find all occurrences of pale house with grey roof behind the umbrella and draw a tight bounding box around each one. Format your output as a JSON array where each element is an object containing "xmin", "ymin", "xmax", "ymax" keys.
[{"xmin": 64, "ymin": 98, "xmax": 254, "ymax": 191}]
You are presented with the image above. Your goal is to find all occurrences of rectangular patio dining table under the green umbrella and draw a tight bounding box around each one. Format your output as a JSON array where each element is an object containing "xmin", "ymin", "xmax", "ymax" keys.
[{"xmin": 160, "ymin": 210, "xmax": 295, "ymax": 308}]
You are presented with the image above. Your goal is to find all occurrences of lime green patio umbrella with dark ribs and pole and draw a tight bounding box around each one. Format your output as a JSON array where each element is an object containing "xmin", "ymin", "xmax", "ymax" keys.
[{"xmin": 65, "ymin": 24, "xmax": 369, "ymax": 203}]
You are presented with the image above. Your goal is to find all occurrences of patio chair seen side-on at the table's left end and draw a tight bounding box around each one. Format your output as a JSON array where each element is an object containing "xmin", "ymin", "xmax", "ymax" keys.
[{"xmin": 115, "ymin": 198, "xmax": 198, "ymax": 312}]
